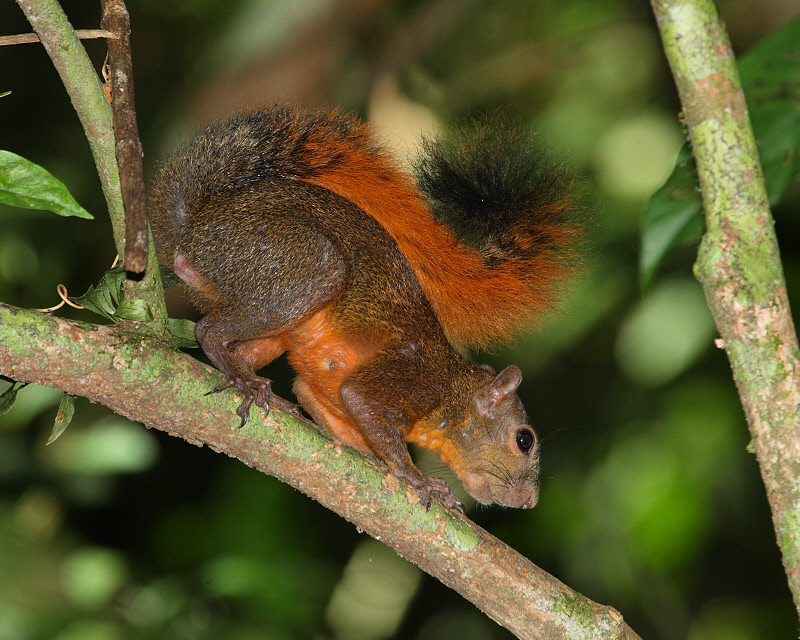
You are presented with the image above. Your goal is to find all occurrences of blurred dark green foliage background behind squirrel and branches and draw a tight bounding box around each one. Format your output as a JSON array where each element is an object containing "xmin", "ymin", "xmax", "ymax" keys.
[{"xmin": 0, "ymin": 0, "xmax": 800, "ymax": 640}]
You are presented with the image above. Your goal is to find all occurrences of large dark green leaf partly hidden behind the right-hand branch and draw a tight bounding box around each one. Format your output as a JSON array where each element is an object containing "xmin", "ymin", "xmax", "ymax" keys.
[{"xmin": 639, "ymin": 18, "xmax": 800, "ymax": 288}]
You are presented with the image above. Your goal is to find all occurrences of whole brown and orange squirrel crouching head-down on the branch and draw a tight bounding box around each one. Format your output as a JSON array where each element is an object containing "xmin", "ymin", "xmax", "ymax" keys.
[{"xmin": 151, "ymin": 105, "xmax": 581, "ymax": 510}]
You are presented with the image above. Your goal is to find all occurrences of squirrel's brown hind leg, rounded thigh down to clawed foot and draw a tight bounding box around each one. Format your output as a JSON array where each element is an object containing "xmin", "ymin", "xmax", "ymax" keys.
[{"xmin": 183, "ymin": 211, "xmax": 347, "ymax": 426}]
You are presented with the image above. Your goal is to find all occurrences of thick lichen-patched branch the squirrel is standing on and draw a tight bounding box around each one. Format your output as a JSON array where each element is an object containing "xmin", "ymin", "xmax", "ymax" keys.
[{"xmin": 0, "ymin": 304, "xmax": 638, "ymax": 640}]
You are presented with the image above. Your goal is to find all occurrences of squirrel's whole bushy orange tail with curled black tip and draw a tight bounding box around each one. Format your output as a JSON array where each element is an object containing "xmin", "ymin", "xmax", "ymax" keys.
[{"xmin": 154, "ymin": 106, "xmax": 579, "ymax": 347}]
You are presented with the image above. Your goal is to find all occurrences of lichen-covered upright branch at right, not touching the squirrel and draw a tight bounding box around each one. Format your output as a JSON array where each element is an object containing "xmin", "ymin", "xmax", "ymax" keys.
[{"xmin": 652, "ymin": 0, "xmax": 800, "ymax": 611}]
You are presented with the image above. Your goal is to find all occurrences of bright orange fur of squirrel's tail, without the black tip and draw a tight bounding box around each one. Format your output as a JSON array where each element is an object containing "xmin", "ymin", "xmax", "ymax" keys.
[{"xmin": 282, "ymin": 110, "xmax": 579, "ymax": 348}]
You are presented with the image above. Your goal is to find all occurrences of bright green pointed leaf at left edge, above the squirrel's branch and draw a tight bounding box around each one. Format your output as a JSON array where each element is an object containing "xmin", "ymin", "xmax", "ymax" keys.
[{"xmin": 0, "ymin": 150, "xmax": 92, "ymax": 220}]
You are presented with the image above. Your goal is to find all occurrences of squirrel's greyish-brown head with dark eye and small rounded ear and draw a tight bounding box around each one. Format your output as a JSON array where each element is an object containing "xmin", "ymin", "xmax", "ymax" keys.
[{"xmin": 448, "ymin": 365, "xmax": 539, "ymax": 509}]
